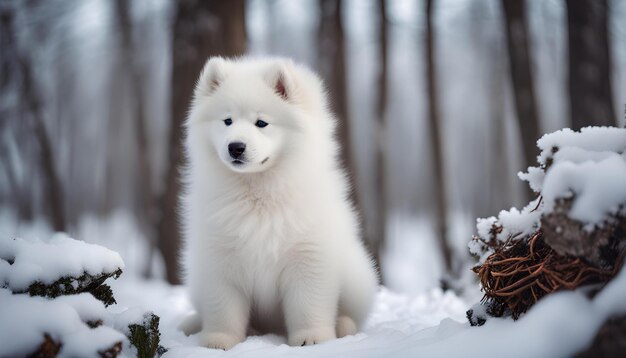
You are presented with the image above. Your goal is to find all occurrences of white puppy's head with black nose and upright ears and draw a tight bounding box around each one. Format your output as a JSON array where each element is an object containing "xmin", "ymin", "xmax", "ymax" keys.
[{"xmin": 189, "ymin": 57, "xmax": 316, "ymax": 173}]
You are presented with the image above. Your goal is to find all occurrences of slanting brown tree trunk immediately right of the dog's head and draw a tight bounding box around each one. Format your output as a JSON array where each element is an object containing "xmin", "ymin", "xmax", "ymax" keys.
[{"xmin": 317, "ymin": 0, "xmax": 370, "ymax": 266}]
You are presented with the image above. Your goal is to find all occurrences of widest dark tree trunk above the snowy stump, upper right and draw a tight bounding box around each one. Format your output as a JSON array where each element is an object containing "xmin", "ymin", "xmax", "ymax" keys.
[{"xmin": 565, "ymin": 0, "xmax": 617, "ymax": 130}]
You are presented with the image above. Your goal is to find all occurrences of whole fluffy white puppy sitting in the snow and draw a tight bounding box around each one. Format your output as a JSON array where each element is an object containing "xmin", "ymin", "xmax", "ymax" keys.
[{"xmin": 180, "ymin": 58, "xmax": 377, "ymax": 349}]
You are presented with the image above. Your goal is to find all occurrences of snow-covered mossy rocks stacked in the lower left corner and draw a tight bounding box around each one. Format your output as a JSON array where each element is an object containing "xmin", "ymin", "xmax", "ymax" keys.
[{"xmin": 0, "ymin": 234, "xmax": 164, "ymax": 357}]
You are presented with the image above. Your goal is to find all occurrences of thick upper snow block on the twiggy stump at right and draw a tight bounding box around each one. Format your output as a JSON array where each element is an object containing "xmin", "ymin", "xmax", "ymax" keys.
[{"xmin": 519, "ymin": 127, "xmax": 626, "ymax": 227}]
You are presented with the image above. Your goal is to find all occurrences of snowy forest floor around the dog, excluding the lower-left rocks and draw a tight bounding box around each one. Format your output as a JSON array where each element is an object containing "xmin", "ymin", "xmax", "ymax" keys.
[{"xmin": 112, "ymin": 272, "xmax": 626, "ymax": 357}]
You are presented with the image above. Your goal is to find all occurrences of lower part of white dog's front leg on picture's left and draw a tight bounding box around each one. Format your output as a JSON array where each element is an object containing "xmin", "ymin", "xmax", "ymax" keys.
[{"xmin": 199, "ymin": 283, "xmax": 250, "ymax": 350}]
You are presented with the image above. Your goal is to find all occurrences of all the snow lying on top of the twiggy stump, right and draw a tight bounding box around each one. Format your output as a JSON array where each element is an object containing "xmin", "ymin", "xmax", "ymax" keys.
[{"xmin": 469, "ymin": 127, "xmax": 626, "ymax": 263}]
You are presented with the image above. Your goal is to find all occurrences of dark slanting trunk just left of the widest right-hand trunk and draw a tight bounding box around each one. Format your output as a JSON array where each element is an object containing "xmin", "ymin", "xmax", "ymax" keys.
[{"xmin": 502, "ymin": 0, "xmax": 540, "ymax": 200}]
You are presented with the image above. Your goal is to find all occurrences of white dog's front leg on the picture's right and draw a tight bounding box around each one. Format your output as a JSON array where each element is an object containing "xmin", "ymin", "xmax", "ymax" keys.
[{"xmin": 281, "ymin": 245, "xmax": 339, "ymax": 346}]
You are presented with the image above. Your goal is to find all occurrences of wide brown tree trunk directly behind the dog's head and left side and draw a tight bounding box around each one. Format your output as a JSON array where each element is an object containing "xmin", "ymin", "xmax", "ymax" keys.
[{"xmin": 157, "ymin": 0, "xmax": 246, "ymax": 283}]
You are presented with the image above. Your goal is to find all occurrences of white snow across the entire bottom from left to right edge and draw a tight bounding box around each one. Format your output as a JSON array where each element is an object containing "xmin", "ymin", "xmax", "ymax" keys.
[{"xmin": 11, "ymin": 264, "xmax": 626, "ymax": 358}]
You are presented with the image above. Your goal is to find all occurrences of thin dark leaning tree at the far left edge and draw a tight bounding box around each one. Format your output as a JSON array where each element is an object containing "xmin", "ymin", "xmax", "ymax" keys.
[{"xmin": 0, "ymin": 6, "xmax": 66, "ymax": 231}]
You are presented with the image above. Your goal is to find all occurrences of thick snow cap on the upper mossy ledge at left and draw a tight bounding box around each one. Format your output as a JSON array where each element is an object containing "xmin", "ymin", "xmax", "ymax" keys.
[{"xmin": 0, "ymin": 234, "xmax": 124, "ymax": 291}]
